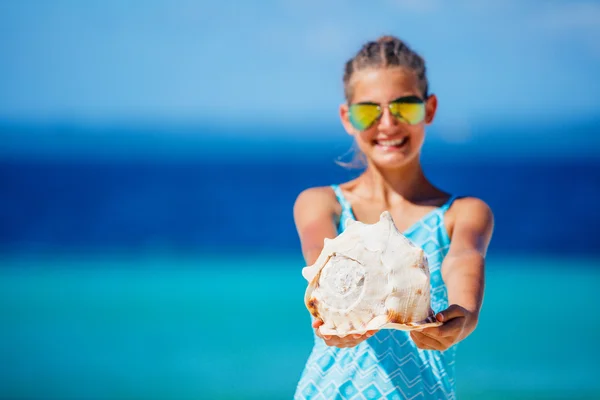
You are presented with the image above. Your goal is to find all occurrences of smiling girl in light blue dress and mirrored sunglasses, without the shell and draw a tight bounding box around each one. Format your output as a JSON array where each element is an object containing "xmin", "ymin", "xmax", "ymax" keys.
[{"xmin": 294, "ymin": 36, "xmax": 493, "ymax": 400}]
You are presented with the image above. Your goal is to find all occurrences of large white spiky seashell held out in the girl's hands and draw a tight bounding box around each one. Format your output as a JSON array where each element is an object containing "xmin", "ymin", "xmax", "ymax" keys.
[{"xmin": 302, "ymin": 211, "xmax": 442, "ymax": 337}]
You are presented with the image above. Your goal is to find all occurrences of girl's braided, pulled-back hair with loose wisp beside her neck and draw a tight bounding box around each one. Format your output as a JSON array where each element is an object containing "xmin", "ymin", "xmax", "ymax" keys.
[{"xmin": 336, "ymin": 36, "xmax": 429, "ymax": 168}]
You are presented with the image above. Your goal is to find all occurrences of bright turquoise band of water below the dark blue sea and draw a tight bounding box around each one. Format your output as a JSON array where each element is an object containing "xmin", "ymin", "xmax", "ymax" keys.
[{"xmin": 0, "ymin": 255, "xmax": 600, "ymax": 400}]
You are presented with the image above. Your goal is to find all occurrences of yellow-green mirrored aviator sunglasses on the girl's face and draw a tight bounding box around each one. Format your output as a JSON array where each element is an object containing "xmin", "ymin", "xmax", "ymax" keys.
[{"xmin": 349, "ymin": 96, "xmax": 425, "ymax": 131}]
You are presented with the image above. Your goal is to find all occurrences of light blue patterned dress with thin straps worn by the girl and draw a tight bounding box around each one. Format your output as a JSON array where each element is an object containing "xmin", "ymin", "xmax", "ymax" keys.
[{"xmin": 294, "ymin": 185, "xmax": 456, "ymax": 400}]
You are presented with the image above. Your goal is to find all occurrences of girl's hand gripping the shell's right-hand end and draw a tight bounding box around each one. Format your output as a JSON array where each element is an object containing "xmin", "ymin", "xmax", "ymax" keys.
[{"xmin": 410, "ymin": 304, "xmax": 477, "ymax": 351}]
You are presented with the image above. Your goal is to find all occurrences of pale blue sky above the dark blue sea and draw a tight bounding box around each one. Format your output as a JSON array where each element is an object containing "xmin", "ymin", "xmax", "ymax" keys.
[{"xmin": 0, "ymin": 0, "xmax": 600, "ymax": 148}]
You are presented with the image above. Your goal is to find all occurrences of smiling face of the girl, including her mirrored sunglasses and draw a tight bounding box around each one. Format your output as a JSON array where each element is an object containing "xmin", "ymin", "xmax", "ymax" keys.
[{"xmin": 340, "ymin": 67, "xmax": 437, "ymax": 169}]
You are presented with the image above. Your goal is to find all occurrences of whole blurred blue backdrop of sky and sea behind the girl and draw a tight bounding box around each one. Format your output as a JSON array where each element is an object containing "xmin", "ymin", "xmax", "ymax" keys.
[{"xmin": 0, "ymin": 0, "xmax": 600, "ymax": 399}]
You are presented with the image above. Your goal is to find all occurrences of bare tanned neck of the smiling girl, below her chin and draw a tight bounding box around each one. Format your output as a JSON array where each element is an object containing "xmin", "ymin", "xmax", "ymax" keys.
[{"xmin": 359, "ymin": 158, "xmax": 436, "ymax": 205}]
